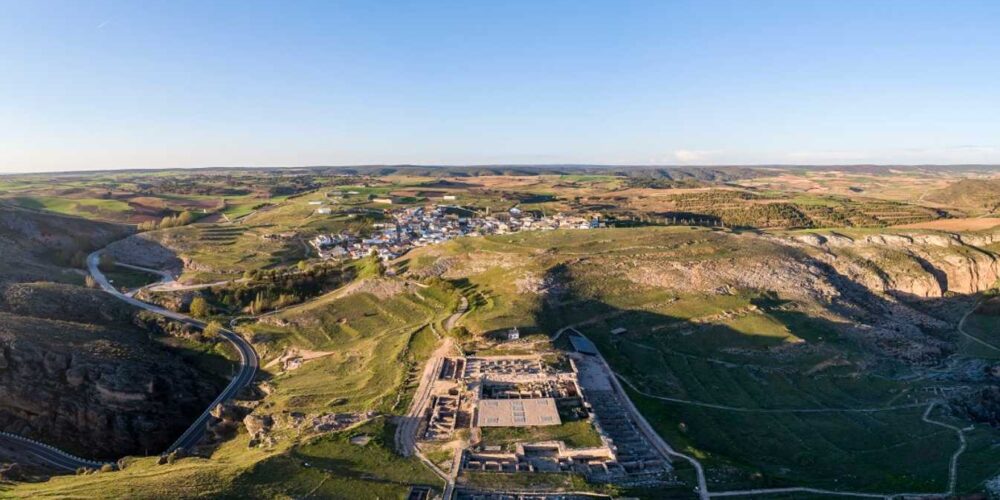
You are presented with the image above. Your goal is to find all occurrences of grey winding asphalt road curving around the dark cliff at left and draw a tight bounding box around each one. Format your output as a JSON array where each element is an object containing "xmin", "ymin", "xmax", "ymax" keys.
[{"xmin": 0, "ymin": 250, "xmax": 260, "ymax": 470}]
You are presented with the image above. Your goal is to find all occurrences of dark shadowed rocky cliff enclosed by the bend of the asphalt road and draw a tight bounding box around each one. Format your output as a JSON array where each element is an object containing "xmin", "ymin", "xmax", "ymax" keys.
[{"xmin": 0, "ymin": 287, "xmax": 218, "ymax": 459}]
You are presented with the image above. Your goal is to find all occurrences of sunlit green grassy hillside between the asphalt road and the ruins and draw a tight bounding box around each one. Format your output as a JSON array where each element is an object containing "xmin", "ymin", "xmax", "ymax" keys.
[{"xmin": 253, "ymin": 282, "xmax": 454, "ymax": 412}]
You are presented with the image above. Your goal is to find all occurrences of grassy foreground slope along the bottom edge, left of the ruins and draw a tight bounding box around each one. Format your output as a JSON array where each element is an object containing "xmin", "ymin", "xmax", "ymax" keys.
[{"xmin": 0, "ymin": 420, "xmax": 439, "ymax": 499}]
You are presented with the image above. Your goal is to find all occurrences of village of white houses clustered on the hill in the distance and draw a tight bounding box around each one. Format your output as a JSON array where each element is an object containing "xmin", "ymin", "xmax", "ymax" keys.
[{"xmin": 310, "ymin": 205, "xmax": 605, "ymax": 261}]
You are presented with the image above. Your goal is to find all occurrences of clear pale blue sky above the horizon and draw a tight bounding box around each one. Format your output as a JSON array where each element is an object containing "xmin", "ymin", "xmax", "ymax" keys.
[{"xmin": 0, "ymin": 0, "xmax": 1000, "ymax": 172}]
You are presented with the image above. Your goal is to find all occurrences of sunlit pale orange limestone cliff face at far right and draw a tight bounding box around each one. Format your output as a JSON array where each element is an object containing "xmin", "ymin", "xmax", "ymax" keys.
[{"xmin": 795, "ymin": 233, "xmax": 1000, "ymax": 298}]
